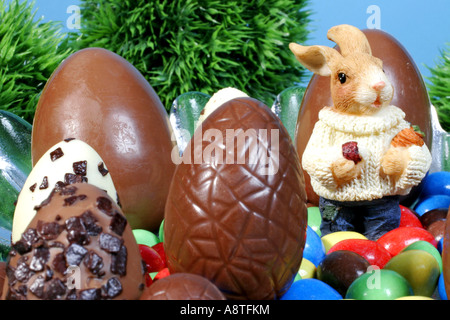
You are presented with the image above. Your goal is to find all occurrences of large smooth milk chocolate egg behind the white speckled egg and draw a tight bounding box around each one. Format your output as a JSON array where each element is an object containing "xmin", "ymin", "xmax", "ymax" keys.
[{"xmin": 31, "ymin": 48, "xmax": 175, "ymax": 230}]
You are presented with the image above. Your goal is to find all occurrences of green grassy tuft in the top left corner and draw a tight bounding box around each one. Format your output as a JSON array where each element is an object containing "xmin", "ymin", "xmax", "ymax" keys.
[{"xmin": 0, "ymin": 0, "xmax": 72, "ymax": 123}]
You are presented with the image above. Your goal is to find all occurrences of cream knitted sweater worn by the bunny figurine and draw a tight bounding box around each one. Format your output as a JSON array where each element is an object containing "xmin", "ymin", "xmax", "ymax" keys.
[{"xmin": 302, "ymin": 106, "xmax": 431, "ymax": 201}]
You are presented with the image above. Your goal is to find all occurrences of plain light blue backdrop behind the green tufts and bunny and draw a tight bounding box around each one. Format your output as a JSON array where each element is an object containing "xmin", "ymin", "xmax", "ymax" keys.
[{"xmin": 16, "ymin": 0, "xmax": 450, "ymax": 85}]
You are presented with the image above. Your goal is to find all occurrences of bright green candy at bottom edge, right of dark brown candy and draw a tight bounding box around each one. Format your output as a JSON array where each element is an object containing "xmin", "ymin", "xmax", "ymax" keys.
[{"xmin": 345, "ymin": 268, "xmax": 413, "ymax": 300}]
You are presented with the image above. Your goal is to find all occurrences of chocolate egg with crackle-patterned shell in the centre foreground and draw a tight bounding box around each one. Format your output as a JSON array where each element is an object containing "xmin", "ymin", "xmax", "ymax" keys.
[{"xmin": 164, "ymin": 98, "xmax": 307, "ymax": 299}]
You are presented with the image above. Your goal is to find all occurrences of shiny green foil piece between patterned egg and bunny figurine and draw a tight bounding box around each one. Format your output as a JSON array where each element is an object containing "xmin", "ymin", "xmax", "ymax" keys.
[{"xmin": 272, "ymin": 86, "xmax": 306, "ymax": 142}]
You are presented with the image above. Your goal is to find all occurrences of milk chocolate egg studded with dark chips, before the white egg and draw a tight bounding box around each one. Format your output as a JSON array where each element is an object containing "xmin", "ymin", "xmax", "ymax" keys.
[{"xmin": 3, "ymin": 183, "xmax": 145, "ymax": 300}]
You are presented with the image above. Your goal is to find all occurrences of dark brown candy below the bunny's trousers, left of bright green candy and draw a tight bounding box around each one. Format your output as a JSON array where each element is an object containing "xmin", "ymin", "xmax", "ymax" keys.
[{"xmin": 317, "ymin": 250, "xmax": 370, "ymax": 296}]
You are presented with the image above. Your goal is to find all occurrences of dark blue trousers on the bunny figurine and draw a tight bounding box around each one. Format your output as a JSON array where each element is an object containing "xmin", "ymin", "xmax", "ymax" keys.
[{"xmin": 319, "ymin": 196, "xmax": 401, "ymax": 241}]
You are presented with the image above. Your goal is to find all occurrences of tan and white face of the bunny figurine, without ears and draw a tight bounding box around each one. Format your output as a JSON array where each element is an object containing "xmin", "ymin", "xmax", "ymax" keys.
[{"xmin": 329, "ymin": 53, "xmax": 394, "ymax": 115}]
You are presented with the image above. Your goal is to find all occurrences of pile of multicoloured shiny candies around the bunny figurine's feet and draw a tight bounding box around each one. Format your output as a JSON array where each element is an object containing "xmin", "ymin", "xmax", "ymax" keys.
[{"xmin": 282, "ymin": 172, "xmax": 450, "ymax": 300}]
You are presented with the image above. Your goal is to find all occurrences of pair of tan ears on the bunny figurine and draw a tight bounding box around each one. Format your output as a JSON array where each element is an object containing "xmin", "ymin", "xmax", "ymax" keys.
[{"xmin": 289, "ymin": 24, "xmax": 372, "ymax": 76}]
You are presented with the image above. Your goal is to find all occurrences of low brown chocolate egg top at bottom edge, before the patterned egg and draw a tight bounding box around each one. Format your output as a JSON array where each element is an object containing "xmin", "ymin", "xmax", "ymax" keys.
[{"xmin": 140, "ymin": 273, "xmax": 225, "ymax": 300}]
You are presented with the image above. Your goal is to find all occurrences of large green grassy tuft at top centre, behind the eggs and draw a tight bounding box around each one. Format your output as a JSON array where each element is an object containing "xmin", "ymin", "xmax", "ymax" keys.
[{"xmin": 70, "ymin": 0, "xmax": 310, "ymax": 111}]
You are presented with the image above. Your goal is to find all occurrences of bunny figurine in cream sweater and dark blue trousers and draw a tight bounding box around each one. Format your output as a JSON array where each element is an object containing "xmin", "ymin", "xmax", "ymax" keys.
[{"xmin": 289, "ymin": 25, "xmax": 431, "ymax": 240}]
